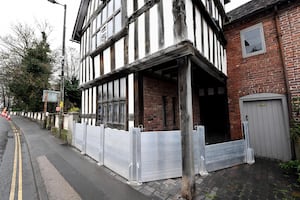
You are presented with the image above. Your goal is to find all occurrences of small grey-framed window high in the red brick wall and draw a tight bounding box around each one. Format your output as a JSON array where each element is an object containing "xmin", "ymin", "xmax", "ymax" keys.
[{"xmin": 241, "ymin": 23, "xmax": 266, "ymax": 58}]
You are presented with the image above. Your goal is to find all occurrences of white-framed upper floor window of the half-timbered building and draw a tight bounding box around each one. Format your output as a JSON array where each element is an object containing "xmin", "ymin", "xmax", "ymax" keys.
[{"xmin": 91, "ymin": 0, "xmax": 122, "ymax": 50}]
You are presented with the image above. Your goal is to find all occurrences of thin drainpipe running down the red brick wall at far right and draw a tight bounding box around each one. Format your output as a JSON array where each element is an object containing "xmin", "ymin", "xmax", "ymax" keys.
[{"xmin": 274, "ymin": 5, "xmax": 296, "ymax": 159}]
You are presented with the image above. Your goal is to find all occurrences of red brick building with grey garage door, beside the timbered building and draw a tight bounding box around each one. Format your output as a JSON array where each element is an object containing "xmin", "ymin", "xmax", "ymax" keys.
[{"xmin": 225, "ymin": 0, "xmax": 300, "ymax": 160}]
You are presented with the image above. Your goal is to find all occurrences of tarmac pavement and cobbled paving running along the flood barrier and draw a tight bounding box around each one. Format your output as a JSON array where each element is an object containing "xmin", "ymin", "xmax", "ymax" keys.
[{"xmin": 8, "ymin": 117, "xmax": 300, "ymax": 200}]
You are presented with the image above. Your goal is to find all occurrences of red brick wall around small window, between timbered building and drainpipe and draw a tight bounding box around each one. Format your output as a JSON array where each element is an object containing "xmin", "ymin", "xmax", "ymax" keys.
[{"xmin": 225, "ymin": 15, "xmax": 286, "ymax": 139}]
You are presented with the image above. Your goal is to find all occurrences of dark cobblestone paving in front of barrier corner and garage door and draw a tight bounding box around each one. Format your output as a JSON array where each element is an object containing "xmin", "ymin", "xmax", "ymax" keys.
[{"xmin": 103, "ymin": 159, "xmax": 300, "ymax": 200}]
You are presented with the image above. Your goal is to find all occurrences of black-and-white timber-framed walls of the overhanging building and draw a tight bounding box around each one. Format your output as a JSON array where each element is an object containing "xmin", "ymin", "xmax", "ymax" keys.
[{"xmin": 72, "ymin": 0, "xmax": 227, "ymax": 129}]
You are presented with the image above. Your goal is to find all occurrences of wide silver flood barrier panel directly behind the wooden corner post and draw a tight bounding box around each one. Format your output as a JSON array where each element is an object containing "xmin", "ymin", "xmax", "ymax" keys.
[{"xmin": 139, "ymin": 130, "xmax": 204, "ymax": 182}]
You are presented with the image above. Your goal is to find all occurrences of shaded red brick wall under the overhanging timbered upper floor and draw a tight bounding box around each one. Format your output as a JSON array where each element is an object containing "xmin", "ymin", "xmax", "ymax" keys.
[{"xmin": 143, "ymin": 77, "xmax": 200, "ymax": 131}]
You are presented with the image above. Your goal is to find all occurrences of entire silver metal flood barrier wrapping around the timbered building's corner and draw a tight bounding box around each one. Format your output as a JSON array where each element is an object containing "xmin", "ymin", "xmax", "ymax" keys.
[{"xmin": 74, "ymin": 123, "xmax": 254, "ymax": 184}]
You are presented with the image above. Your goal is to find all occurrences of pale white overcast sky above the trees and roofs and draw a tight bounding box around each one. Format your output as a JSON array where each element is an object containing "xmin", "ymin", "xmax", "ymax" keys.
[{"xmin": 0, "ymin": 0, "xmax": 249, "ymax": 49}]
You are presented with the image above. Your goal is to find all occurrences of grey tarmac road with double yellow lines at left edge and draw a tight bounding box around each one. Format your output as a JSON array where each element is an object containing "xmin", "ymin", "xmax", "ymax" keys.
[{"xmin": 0, "ymin": 117, "xmax": 38, "ymax": 200}]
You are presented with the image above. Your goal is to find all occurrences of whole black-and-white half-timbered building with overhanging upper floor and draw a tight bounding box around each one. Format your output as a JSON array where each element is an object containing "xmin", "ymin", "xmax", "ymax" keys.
[{"xmin": 72, "ymin": 0, "xmax": 229, "ymax": 143}]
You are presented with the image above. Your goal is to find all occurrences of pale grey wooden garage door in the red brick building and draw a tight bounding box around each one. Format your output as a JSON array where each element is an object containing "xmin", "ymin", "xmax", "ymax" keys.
[{"xmin": 242, "ymin": 95, "xmax": 291, "ymax": 161}]
